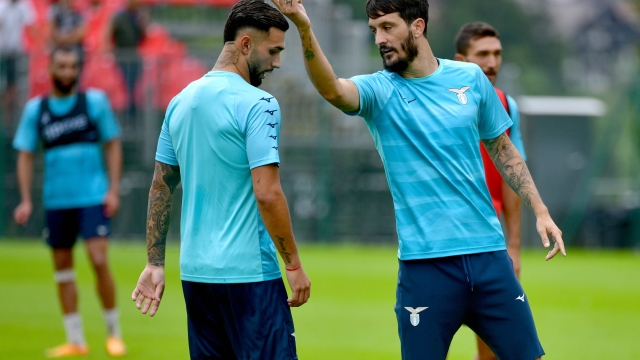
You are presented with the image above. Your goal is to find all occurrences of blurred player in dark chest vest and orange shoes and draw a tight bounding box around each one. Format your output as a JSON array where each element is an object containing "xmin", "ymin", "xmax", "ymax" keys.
[{"xmin": 13, "ymin": 47, "xmax": 126, "ymax": 358}]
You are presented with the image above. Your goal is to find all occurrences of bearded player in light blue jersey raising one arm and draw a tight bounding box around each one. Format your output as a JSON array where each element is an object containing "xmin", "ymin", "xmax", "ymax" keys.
[{"xmin": 274, "ymin": 0, "xmax": 565, "ymax": 360}]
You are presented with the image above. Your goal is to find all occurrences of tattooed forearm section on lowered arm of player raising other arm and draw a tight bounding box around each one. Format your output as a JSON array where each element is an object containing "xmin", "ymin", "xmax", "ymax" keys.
[{"xmin": 482, "ymin": 133, "xmax": 542, "ymax": 208}]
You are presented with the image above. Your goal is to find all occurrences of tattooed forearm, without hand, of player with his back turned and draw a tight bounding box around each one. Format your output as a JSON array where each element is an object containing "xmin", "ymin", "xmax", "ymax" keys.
[{"xmin": 147, "ymin": 162, "xmax": 180, "ymax": 266}]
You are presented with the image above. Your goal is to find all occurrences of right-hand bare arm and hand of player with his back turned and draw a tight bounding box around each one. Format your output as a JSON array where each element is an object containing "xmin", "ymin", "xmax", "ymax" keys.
[{"xmin": 251, "ymin": 164, "xmax": 311, "ymax": 307}]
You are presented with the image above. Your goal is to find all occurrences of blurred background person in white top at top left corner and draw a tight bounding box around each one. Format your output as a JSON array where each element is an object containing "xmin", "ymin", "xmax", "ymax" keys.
[{"xmin": 0, "ymin": 0, "xmax": 35, "ymax": 125}]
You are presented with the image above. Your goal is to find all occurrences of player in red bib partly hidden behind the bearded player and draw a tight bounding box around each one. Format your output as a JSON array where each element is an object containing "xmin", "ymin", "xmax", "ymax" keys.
[{"xmin": 454, "ymin": 22, "xmax": 526, "ymax": 360}]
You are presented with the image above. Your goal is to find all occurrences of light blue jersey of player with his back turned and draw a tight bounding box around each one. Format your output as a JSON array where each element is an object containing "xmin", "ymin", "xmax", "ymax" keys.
[{"xmin": 156, "ymin": 71, "xmax": 281, "ymax": 283}]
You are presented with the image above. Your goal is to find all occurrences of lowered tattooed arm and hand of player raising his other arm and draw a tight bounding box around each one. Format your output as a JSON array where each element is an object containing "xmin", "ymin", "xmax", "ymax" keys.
[{"xmin": 482, "ymin": 133, "xmax": 567, "ymax": 260}]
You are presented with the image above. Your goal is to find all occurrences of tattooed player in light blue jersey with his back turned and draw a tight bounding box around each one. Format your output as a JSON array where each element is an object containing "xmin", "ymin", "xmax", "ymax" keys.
[{"xmin": 132, "ymin": 0, "xmax": 311, "ymax": 360}]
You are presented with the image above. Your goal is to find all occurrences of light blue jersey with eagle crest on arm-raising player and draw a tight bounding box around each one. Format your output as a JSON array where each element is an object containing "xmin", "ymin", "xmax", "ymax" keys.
[{"xmin": 350, "ymin": 59, "xmax": 512, "ymax": 260}]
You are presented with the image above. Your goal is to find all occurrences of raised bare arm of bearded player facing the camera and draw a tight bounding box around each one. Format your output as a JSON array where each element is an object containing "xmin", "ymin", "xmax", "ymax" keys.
[{"xmin": 272, "ymin": 0, "xmax": 360, "ymax": 112}]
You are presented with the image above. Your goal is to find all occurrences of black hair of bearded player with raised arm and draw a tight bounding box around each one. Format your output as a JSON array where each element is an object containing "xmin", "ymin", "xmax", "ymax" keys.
[{"xmin": 366, "ymin": 0, "xmax": 429, "ymax": 37}]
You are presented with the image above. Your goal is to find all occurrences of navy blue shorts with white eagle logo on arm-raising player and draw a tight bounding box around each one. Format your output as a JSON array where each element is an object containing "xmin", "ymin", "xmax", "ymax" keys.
[{"xmin": 395, "ymin": 251, "xmax": 544, "ymax": 360}]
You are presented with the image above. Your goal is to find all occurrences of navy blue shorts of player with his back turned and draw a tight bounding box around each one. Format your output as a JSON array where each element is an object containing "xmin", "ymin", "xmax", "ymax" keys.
[{"xmin": 182, "ymin": 279, "xmax": 298, "ymax": 360}]
